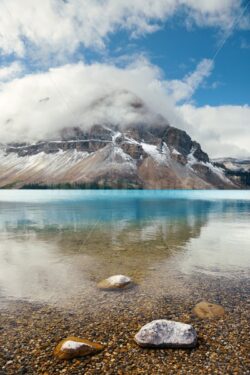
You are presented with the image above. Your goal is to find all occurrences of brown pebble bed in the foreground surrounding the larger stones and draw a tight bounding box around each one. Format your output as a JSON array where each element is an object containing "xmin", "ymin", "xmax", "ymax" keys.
[{"xmin": 0, "ymin": 276, "xmax": 250, "ymax": 375}]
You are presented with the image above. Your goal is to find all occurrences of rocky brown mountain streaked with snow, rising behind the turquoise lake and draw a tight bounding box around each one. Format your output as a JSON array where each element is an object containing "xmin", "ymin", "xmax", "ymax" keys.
[{"xmin": 0, "ymin": 93, "xmax": 239, "ymax": 189}]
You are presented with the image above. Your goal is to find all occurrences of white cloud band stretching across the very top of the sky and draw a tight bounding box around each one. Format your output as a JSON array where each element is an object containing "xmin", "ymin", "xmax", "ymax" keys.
[{"xmin": 0, "ymin": 0, "xmax": 246, "ymax": 61}]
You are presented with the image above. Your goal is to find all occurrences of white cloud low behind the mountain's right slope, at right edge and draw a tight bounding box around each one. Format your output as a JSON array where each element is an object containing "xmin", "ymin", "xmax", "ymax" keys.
[{"xmin": 178, "ymin": 105, "xmax": 250, "ymax": 157}]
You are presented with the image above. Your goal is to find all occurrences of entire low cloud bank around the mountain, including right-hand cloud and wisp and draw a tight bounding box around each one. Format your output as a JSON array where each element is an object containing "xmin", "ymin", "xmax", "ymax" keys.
[{"xmin": 0, "ymin": 59, "xmax": 247, "ymax": 157}]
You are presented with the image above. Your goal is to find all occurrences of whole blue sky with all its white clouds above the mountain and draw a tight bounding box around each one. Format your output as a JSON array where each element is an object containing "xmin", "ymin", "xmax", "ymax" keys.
[{"xmin": 0, "ymin": 0, "xmax": 250, "ymax": 157}]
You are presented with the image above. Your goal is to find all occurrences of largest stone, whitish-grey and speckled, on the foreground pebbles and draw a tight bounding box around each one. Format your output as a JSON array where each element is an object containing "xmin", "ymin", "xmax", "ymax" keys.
[{"xmin": 135, "ymin": 319, "xmax": 197, "ymax": 348}]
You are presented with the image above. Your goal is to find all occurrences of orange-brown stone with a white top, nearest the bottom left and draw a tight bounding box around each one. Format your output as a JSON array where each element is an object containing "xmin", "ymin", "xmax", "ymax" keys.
[{"xmin": 54, "ymin": 336, "xmax": 104, "ymax": 359}]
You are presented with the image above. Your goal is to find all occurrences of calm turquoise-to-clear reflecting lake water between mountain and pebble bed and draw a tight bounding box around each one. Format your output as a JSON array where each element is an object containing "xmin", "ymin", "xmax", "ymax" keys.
[{"xmin": 0, "ymin": 190, "xmax": 250, "ymax": 302}]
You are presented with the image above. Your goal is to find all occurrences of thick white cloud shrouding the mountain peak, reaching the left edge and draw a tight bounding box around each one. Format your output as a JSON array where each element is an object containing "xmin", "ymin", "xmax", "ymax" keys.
[{"xmin": 0, "ymin": 60, "xmax": 174, "ymax": 143}]
